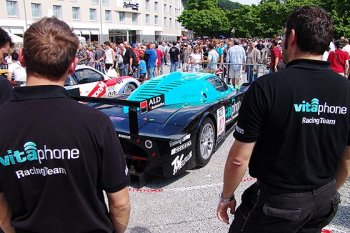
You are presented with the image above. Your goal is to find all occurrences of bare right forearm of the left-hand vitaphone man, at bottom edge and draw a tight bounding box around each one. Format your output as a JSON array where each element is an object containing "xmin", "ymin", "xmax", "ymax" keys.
[{"xmin": 107, "ymin": 187, "xmax": 131, "ymax": 233}]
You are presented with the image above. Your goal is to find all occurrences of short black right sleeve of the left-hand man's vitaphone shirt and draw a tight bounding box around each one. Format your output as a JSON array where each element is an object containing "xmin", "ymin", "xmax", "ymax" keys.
[{"xmin": 101, "ymin": 121, "xmax": 129, "ymax": 192}]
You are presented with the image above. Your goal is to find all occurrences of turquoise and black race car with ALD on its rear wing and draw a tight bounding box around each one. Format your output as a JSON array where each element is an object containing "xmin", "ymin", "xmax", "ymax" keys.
[{"xmin": 79, "ymin": 72, "xmax": 248, "ymax": 185}]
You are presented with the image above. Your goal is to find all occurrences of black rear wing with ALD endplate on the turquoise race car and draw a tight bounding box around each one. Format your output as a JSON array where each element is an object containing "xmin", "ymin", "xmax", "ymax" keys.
[{"xmin": 71, "ymin": 94, "xmax": 165, "ymax": 135}]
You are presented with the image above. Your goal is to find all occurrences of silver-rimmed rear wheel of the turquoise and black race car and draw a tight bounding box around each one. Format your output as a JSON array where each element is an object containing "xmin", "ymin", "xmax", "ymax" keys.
[{"xmin": 196, "ymin": 118, "xmax": 215, "ymax": 167}]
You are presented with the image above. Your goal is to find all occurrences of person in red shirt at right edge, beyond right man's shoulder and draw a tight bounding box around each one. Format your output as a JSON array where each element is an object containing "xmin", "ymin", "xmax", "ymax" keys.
[{"xmin": 328, "ymin": 40, "xmax": 349, "ymax": 78}]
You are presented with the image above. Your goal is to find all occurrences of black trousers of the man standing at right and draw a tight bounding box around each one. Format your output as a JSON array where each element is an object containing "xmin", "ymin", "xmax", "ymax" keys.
[{"xmin": 229, "ymin": 181, "xmax": 340, "ymax": 233}]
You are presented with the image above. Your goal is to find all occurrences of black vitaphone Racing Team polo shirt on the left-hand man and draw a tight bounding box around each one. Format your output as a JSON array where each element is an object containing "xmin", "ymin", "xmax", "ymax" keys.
[{"xmin": 0, "ymin": 86, "xmax": 129, "ymax": 233}]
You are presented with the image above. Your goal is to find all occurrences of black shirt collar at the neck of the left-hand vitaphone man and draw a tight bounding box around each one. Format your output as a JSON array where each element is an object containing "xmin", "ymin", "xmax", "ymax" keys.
[{"xmin": 12, "ymin": 85, "xmax": 69, "ymax": 101}]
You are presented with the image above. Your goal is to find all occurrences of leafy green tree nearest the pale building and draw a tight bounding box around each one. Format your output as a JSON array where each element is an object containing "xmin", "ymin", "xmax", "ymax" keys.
[{"xmin": 177, "ymin": 0, "xmax": 230, "ymax": 36}]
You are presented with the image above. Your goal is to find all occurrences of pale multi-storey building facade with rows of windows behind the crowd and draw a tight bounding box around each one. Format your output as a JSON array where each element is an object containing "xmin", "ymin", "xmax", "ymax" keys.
[{"xmin": 0, "ymin": 0, "xmax": 183, "ymax": 42}]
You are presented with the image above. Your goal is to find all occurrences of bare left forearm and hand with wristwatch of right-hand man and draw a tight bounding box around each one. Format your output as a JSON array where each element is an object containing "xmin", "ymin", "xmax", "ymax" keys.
[{"xmin": 216, "ymin": 140, "xmax": 255, "ymax": 224}]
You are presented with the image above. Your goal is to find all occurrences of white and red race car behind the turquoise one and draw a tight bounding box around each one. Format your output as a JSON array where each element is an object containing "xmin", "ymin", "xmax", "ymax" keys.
[{"xmin": 65, "ymin": 65, "xmax": 140, "ymax": 98}]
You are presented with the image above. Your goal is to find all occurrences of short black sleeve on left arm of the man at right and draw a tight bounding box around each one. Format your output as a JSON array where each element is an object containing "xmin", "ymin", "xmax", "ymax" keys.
[{"xmin": 233, "ymin": 82, "xmax": 268, "ymax": 142}]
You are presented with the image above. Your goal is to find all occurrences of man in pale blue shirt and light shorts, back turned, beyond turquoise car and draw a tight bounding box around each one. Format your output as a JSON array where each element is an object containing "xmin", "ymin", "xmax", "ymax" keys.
[{"xmin": 226, "ymin": 38, "xmax": 247, "ymax": 88}]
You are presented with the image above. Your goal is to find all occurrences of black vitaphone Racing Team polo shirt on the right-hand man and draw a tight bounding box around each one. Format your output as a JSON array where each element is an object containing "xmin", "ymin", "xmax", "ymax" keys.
[{"xmin": 234, "ymin": 60, "xmax": 350, "ymax": 191}]
